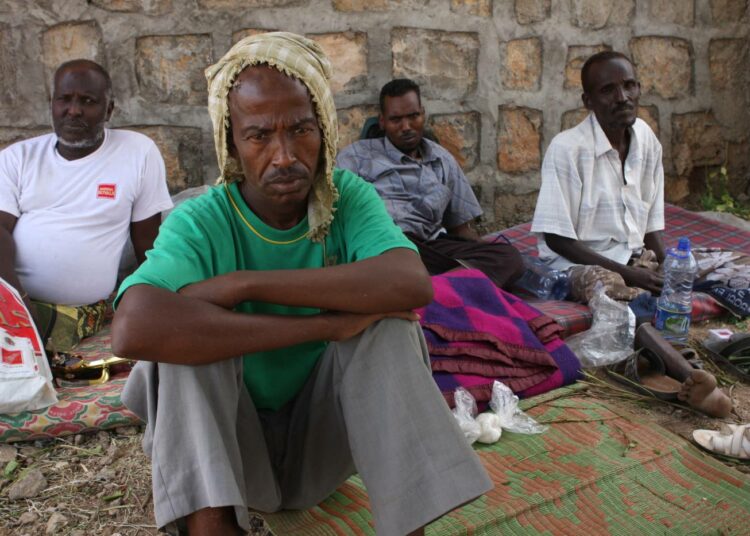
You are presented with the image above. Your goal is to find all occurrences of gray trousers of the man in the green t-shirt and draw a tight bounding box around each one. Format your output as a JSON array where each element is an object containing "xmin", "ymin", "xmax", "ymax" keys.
[{"xmin": 122, "ymin": 319, "xmax": 492, "ymax": 536}]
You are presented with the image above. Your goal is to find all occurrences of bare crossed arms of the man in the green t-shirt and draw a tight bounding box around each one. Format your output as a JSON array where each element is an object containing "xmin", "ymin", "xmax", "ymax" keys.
[{"xmin": 112, "ymin": 248, "xmax": 432, "ymax": 365}]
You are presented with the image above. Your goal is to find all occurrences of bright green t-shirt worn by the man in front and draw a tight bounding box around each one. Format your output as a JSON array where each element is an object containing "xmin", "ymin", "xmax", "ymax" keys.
[{"xmin": 120, "ymin": 169, "xmax": 416, "ymax": 410}]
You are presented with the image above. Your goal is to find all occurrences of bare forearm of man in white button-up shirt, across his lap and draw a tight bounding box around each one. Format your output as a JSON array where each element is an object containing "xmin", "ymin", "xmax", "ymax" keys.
[{"xmin": 544, "ymin": 233, "xmax": 663, "ymax": 294}]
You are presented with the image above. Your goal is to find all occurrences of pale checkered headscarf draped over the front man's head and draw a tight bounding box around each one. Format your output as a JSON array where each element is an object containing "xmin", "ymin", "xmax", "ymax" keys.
[{"xmin": 206, "ymin": 32, "xmax": 338, "ymax": 241}]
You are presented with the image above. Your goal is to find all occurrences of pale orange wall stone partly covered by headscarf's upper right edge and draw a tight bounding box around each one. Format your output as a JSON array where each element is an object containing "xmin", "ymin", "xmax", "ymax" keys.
[{"xmin": 308, "ymin": 32, "xmax": 367, "ymax": 94}]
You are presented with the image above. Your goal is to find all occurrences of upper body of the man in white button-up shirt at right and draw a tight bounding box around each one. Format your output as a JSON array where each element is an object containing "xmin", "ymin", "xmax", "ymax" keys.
[{"xmin": 531, "ymin": 52, "xmax": 664, "ymax": 294}]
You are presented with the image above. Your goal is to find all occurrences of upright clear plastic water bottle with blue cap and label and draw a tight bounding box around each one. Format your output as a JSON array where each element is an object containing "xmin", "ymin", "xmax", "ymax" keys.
[{"xmin": 654, "ymin": 237, "xmax": 698, "ymax": 343}]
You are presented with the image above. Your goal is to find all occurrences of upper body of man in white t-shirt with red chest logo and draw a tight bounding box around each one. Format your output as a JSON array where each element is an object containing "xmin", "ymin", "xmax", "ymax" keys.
[{"xmin": 0, "ymin": 60, "xmax": 172, "ymax": 322}]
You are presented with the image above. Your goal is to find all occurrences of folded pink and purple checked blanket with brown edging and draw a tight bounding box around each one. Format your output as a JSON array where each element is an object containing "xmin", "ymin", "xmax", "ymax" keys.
[{"xmin": 417, "ymin": 270, "xmax": 581, "ymax": 409}]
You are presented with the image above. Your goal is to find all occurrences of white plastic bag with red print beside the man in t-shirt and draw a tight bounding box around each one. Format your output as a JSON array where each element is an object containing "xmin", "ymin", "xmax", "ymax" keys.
[{"xmin": 0, "ymin": 278, "xmax": 57, "ymax": 413}]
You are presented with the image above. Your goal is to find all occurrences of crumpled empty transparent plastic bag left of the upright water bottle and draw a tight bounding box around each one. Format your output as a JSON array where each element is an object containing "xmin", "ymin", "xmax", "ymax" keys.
[{"xmin": 565, "ymin": 286, "xmax": 635, "ymax": 368}]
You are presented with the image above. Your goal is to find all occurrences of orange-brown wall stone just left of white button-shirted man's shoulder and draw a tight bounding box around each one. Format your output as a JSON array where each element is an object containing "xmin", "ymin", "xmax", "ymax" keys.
[{"xmin": 497, "ymin": 106, "xmax": 542, "ymax": 174}]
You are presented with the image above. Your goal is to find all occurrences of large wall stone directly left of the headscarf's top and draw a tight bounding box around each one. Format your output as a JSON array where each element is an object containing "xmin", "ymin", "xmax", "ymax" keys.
[{"xmin": 135, "ymin": 34, "xmax": 212, "ymax": 105}]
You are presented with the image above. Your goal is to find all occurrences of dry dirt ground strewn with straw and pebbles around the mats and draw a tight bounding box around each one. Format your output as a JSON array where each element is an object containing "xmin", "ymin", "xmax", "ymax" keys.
[{"xmin": 0, "ymin": 321, "xmax": 750, "ymax": 536}]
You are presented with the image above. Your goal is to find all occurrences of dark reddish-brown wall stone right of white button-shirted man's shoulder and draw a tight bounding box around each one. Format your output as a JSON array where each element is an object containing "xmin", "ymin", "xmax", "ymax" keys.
[{"xmin": 672, "ymin": 111, "xmax": 726, "ymax": 175}]
